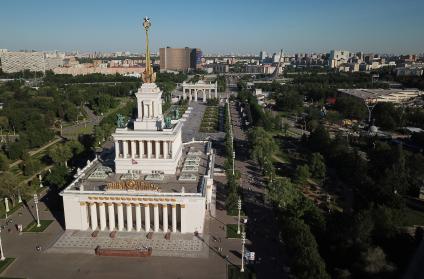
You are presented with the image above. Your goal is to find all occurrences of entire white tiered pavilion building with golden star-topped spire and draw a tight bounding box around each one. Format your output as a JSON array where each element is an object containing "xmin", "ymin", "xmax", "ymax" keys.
[{"xmin": 60, "ymin": 18, "xmax": 215, "ymax": 236}]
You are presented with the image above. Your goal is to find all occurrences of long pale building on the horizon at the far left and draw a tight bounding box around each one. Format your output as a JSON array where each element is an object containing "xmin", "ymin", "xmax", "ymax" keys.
[{"xmin": 0, "ymin": 51, "xmax": 63, "ymax": 73}]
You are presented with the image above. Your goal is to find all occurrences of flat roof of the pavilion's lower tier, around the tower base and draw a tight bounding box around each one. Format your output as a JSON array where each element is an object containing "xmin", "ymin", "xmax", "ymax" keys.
[{"xmin": 65, "ymin": 142, "xmax": 214, "ymax": 194}]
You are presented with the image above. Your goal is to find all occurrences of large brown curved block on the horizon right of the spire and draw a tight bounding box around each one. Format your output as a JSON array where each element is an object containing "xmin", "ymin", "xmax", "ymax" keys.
[{"xmin": 159, "ymin": 47, "xmax": 202, "ymax": 72}]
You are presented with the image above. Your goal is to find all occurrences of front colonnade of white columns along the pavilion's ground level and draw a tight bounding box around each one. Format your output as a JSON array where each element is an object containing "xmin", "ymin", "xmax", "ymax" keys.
[{"xmin": 80, "ymin": 202, "xmax": 185, "ymax": 233}]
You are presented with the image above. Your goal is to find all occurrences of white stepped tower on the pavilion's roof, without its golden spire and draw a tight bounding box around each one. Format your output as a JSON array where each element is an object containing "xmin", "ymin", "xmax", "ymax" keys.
[{"xmin": 112, "ymin": 83, "xmax": 182, "ymax": 174}]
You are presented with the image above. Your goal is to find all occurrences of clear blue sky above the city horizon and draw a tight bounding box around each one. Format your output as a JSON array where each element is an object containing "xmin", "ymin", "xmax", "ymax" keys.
[{"xmin": 0, "ymin": 0, "xmax": 424, "ymax": 53}]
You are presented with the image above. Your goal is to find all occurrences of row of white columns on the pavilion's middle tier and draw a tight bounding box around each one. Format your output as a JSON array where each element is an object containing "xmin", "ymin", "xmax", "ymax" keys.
[{"xmin": 115, "ymin": 140, "xmax": 172, "ymax": 159}]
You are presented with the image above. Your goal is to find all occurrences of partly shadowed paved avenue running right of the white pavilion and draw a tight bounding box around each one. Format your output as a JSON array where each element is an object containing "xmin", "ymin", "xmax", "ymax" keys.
[{"xmin": 230, "ymin": 103, "xmax": 286, "ymax": 278}]
